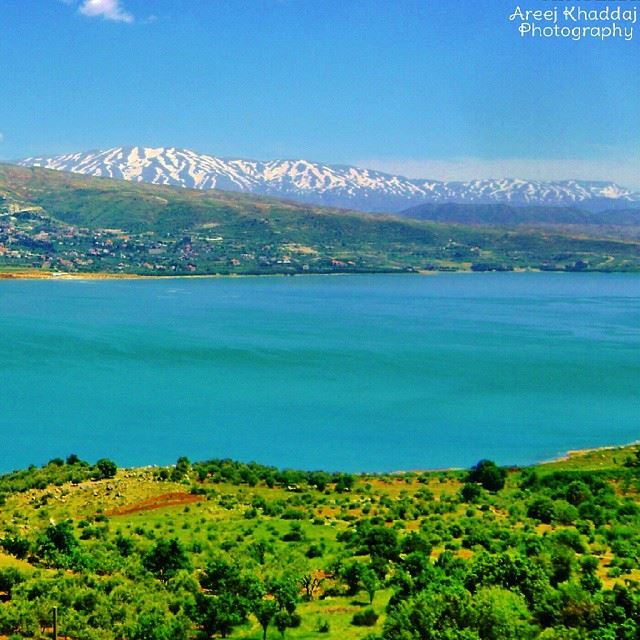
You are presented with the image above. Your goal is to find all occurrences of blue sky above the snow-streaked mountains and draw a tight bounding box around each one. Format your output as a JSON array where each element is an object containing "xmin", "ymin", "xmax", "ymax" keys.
[{"xmin": 0, "ymin": 0, "xmax": 640, "ymax": 187}]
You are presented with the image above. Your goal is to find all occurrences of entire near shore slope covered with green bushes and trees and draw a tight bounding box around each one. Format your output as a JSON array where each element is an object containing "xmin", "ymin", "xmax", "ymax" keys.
[{"xmin": 0, "ymin": 447, "xmax": 640, "ymax": 640}]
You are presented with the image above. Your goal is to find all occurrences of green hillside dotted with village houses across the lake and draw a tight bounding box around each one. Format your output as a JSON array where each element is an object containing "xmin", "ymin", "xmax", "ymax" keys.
[{"xmin": 0, "ymin": 165, "xmax": 640, "ymax": 275}]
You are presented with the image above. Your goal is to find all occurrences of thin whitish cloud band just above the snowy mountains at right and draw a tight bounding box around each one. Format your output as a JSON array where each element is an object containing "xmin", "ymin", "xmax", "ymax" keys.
[{"xmin": 354, "ymin": 157, "xmax": 640, "ymax": 189}]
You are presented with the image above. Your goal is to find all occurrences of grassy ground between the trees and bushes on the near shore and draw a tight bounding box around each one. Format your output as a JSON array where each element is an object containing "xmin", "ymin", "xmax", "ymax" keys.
[{"xmin": 0, "ymin": 445, "xmax": 640, "ymax": 640}]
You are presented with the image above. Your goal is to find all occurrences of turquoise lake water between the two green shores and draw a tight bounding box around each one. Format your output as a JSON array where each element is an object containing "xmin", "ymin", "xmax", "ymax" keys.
[{"xmin": 0, "ymin": 274, "xmax": 640, "ymax": 471}]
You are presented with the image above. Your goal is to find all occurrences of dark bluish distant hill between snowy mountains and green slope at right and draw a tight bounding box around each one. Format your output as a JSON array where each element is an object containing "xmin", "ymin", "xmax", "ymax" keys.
[{"xmin": 399, "ymin": 203, "xmax": 640, "ymax": 226}]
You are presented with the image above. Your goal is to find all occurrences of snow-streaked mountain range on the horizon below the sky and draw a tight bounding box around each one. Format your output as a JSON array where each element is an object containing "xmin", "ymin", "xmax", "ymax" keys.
[{"xmin": 18, "ymin": 147, "xmax": 640, "ymax": 212}]
